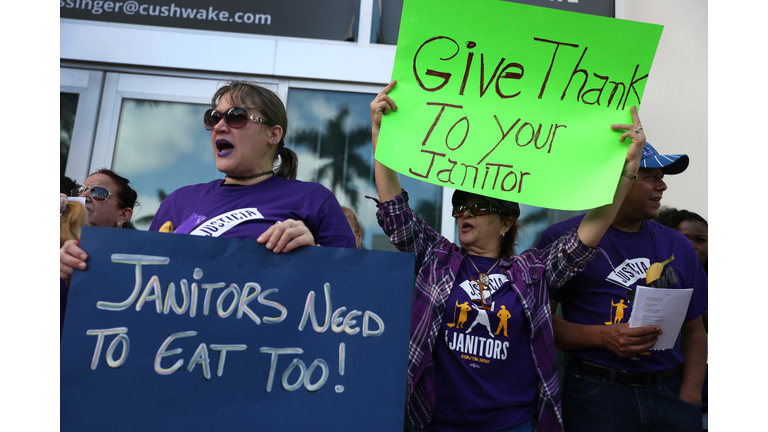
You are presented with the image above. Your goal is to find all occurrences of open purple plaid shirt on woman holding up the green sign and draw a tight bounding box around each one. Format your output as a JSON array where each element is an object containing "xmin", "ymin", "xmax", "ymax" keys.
[{"xmin": 376, "ymin": 190, "xmax": 597, "ymax": 431}]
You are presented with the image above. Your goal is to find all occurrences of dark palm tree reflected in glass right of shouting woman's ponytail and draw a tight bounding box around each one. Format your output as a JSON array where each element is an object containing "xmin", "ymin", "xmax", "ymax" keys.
[{"xmin": 292, "ymin": 106, "xmax": 371, "ymax": 207}]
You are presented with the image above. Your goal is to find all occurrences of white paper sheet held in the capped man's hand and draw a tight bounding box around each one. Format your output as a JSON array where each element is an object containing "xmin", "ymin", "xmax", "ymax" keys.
[{"xmin": 629, "ymin": 286, "xmax": 693, "ymax": 349}]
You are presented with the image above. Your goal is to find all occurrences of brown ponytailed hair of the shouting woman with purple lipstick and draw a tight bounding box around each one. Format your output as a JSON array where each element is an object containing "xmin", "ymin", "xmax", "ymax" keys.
[{"xmin": 211, "ymin": 81, "xmax": 299, "ymax": 179}]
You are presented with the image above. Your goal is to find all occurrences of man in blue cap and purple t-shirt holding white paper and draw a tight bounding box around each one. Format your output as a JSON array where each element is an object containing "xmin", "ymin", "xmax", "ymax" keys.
[{"xmin": 537, "ymin": 143, "xmax": 708, "ymax": 432}]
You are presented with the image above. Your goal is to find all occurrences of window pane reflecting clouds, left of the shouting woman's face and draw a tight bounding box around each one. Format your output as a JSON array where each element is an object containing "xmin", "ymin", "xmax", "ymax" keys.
[{"xmin": 108, "ymin": 99, "xmax": 218, "ymax": 230}]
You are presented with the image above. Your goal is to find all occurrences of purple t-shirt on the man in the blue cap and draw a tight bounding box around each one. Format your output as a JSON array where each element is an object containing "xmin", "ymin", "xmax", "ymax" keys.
[{"xmin": 536, "ymin": 215, "xmax": 708, "ymax": 372}]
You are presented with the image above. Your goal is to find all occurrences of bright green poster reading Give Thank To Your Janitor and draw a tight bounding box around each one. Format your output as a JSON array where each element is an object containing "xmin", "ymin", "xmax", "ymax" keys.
[{"xmin": 376, "ymin": 0, "xmax": 662, "ymax": 210}]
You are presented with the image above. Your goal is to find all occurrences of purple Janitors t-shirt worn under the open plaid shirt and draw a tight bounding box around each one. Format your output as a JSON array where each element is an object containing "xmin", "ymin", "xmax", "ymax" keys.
[{"xmin": 427, "ymin": 256, "xmax": 539, "ymax": 432}]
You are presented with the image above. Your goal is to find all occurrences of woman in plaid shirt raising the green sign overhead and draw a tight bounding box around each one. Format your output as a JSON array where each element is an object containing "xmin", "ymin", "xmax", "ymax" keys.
[{"xmin": 371, "ymin": 81, "xmax": 645, "ymax": 432}]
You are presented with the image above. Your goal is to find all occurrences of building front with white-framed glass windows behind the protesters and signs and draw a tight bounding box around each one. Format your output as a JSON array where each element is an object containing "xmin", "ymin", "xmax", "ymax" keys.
[{"xmin": 60, "ymin": 0, "xmax": 706, "ymax": 250}]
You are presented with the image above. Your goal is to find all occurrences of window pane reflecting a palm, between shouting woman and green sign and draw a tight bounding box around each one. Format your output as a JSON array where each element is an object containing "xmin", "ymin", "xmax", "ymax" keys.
[{"xmin": 286, "ymin": 88, "xmax": 442, "ymax": 250}]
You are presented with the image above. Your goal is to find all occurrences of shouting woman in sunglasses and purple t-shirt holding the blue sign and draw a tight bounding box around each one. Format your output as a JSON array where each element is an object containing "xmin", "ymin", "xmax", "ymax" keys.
[{"xmin": 61, "ymin": 81, "xmax": 355, "ymax": 286}]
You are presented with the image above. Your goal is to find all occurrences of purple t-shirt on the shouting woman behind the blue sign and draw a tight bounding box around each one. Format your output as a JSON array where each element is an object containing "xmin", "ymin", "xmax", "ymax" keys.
[{"xmin": 149, "ymin": 176, "xmax": 356, "ymax": 248}]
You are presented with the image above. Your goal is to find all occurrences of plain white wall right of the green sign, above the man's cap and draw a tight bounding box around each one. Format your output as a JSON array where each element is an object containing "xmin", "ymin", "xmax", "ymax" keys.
[{"xmin": 616, "ymin": 0, "xmax": 709, "ymax": 219}]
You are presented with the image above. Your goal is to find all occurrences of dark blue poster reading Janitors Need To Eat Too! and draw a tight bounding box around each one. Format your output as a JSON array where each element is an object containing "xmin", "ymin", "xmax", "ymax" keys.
[{"xmin": 61, "ymin": 227, "xmax": 414, "ymax": 432}]
